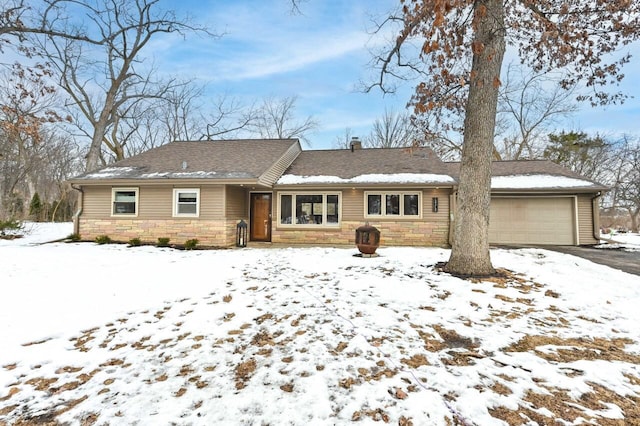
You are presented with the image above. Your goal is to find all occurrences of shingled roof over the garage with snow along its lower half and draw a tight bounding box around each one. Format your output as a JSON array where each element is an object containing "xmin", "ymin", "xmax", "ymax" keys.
[{"xmin": 444, "ymin": 160, "xmax": 608, "ymax": 191}]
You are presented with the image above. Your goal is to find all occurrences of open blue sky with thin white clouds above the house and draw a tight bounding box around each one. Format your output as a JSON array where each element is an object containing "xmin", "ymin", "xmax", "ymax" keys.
[{"xmin": 152, "ymin": 0, "xmax": 640, "ymax": 149}]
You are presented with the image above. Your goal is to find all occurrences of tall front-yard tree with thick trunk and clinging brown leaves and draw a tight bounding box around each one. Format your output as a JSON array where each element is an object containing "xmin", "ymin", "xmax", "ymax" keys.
[{"xmin": 373, "ymin": 0, "xmax": 640, "ymax": 275}]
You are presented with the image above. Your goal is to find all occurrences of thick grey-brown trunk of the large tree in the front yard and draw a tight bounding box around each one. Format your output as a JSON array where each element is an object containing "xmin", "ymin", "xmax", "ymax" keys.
[{"xmin": 445, "ymin": 0, "xmax": 505, "ymax": 275}]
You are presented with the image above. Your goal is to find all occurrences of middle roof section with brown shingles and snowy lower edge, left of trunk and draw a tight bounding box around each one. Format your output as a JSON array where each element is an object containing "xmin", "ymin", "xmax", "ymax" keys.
[{"xmin": 278, "ymin": 148, "xmax": 455, "ymax": 185}]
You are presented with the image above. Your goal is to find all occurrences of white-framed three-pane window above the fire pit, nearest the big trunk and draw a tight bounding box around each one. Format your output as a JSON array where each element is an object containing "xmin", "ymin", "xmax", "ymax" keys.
[{"xmin": 364, "ymin": 192, "xmax": 421, "ymax": 217}]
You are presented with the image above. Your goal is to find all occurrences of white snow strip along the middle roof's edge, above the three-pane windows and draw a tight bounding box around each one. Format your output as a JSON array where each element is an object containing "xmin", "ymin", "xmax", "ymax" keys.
[{"xmin": 277, "ymin": 173, "xmax": 455, "ymax": 185}]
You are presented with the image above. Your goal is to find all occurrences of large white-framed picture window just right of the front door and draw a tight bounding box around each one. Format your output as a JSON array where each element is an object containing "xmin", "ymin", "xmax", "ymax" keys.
[{"xmin": 279, "ymin": 192, "xmax": 340, "ymax": 226}]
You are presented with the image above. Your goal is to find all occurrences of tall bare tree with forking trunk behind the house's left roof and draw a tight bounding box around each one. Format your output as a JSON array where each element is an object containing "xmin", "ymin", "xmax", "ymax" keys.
[{"xmin": 28, "ymin": 0, "xmax": 215, "ymax": 169}]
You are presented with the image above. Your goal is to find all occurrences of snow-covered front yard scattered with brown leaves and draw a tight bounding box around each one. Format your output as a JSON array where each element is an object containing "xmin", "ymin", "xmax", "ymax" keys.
[{"xmin": 0, "ymin": 224, "xmax": 640, "ymax": 425}]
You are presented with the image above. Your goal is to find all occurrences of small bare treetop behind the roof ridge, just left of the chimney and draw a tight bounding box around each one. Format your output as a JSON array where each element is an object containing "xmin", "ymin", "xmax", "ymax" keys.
[{"xmin": 251, "ymin": 96, "xmax": 318, "ymax": 144}]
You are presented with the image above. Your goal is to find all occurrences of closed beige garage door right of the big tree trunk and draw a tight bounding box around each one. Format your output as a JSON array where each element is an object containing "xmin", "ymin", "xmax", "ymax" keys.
[{"xmin": 489, "ymin": 198, "xmax": 575, "ymax": 245}]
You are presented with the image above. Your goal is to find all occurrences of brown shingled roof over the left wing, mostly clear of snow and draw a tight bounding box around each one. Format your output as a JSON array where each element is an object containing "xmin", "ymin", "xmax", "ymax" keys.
[{"xmin": 71, "ymin": 139, "xmax": 300, "ymax": 183}]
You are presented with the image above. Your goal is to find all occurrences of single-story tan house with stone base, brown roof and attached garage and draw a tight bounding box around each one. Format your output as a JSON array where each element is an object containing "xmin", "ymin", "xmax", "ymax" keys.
[{"xmin": 70, "ymin": 139, "xmax": 606, "ymax": 246}]
